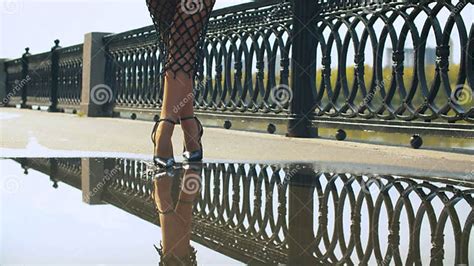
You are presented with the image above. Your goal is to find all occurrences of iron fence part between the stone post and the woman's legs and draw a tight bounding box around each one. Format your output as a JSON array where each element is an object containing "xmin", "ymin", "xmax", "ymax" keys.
[{"xmin": 104, "ymin": 27, "xmax": 163, "ymax": 108}]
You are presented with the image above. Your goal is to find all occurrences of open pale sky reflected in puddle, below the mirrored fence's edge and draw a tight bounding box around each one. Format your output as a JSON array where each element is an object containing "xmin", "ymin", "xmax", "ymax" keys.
[{"xmin": 0, "ymin": 160, "xmax": 238, "ymax": 265}]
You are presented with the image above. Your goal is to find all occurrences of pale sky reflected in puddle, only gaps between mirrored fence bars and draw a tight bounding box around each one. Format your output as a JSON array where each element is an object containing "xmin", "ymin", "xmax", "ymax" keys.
[{"xmin": 244, "ymin": 167, "xmax": 474, "ymax": 265}]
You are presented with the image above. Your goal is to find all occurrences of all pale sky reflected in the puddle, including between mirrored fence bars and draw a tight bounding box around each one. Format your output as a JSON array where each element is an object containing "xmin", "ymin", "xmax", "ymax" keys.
[{"xmin": 0, "ymin": 160, "xmax": 474, "ymax": 265}]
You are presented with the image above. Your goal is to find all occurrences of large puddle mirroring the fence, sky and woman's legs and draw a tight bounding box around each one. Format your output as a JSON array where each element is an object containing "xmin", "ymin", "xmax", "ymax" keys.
[{"xmin": 0, "ymin": 157, "xmax": 474, "ymax": 265}]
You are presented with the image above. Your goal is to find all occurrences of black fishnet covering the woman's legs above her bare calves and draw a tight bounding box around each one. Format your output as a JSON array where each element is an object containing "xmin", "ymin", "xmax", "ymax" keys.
[{"xmin": 146, "ymin": 0, "xmax": 215, "ymax": 78}]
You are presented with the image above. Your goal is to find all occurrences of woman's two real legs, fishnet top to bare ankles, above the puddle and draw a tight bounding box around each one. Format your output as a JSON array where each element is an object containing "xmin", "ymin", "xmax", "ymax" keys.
[{"xmin": 147, "ymin": 0, "xmax": 215, "ymax": 157}]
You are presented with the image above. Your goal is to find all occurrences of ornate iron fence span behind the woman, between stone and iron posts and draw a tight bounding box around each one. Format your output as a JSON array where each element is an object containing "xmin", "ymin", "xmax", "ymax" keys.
[{"xmin": 104, "ymin": 1, "xmax": 292, "ymax": 113}]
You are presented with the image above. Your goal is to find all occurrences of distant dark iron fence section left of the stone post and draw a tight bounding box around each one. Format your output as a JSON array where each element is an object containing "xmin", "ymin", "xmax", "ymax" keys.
[{"xmin": 5, "ymin": 41, "xmax": 83, "ymax": 109}]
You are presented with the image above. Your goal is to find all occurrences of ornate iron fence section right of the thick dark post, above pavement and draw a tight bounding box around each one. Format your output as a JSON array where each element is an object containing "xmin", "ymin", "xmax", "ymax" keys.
[{"xmin": 315, "ymin": 0, "xmax": 474, "ymax": 122}]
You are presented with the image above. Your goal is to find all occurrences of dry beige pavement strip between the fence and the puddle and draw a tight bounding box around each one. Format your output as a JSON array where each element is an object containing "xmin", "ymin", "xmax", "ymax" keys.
[{"xmin": 0, "ymin": 108, "xmax": 474, "ymax": 178}]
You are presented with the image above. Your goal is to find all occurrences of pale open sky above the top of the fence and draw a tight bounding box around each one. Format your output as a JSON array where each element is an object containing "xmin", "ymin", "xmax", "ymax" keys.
[{"xmin": 0, "ymin": 0, "xmax": 250, "ymax": 58}]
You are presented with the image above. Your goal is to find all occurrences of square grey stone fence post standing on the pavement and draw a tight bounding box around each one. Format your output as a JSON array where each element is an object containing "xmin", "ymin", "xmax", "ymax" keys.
[{"xmin": 81, "ymin": 32, "xmax": 113, "ymax": 117}]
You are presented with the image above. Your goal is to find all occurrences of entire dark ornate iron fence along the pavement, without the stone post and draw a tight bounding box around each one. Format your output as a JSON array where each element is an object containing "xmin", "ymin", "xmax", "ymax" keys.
[{"xmin": 1, "ymin": 0, "xmax": 474, "ymax": 137}]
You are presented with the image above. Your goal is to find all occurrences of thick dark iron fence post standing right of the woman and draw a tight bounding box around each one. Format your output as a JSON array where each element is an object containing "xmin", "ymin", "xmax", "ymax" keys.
[{"xmin": 286, "ymin": 0, "xmax": 319, "ymax": 138}]
